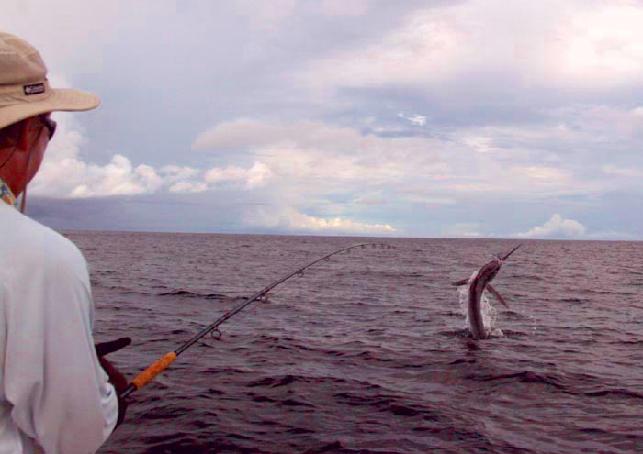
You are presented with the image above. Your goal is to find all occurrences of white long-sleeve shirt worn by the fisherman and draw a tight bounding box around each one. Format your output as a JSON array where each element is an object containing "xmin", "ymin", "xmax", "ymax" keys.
[{"xmin": 0, "ymin": 202, "xmax": 118, "ymax": 454}]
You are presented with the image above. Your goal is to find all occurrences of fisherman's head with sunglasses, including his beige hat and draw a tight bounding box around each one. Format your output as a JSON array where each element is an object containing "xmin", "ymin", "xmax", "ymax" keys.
[{"xmin": 0, "ymin": 31, "xmax": 100, "ymax": 210}]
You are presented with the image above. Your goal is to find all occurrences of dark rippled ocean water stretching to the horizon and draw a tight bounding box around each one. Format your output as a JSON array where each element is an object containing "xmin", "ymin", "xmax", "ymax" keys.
[{"xmin": 67, "ymin": 232, "xmax": 643, "ymax": 453}]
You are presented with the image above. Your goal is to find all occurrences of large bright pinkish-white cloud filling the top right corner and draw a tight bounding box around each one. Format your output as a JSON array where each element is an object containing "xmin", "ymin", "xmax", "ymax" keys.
[{"xmin": 296, "ymin": 0, "xmax": 643, "ymax": 93}]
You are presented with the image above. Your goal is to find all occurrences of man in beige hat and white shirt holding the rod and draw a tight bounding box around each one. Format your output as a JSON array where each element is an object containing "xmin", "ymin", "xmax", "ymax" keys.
[{"xmin": 0, "ymin": 32, "xmax": 126, "ymax": 454}]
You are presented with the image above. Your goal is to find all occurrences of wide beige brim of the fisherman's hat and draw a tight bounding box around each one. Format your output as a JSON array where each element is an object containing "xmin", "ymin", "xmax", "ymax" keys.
[{"xmin": 0, "ymin": 88, "xmax": 100, "ymax": 128}]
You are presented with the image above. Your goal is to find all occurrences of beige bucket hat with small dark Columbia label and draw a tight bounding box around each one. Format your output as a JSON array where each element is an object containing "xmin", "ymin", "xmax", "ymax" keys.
[{"xmin": 0, "ymin": 31, "xmax": 100, "ymax": 128}]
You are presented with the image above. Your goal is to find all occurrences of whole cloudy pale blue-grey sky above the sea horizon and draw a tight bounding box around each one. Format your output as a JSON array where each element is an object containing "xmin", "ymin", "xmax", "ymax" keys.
[{"xmin": 0, "ymin": 0, "xmax": 643, "ymax": 240}]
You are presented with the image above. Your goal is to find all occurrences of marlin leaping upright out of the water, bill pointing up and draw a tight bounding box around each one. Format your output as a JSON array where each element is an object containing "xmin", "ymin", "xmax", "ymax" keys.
[{"xmin": 453, "ymin": 244, "xmax": 522, "ymax": 339}]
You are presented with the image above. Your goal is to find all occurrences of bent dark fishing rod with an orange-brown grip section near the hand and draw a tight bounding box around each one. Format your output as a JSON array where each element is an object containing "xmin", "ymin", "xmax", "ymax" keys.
[{"xmin": 121, "ymin": 243, "xmax": 390, "ymax": 397}]
